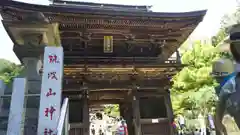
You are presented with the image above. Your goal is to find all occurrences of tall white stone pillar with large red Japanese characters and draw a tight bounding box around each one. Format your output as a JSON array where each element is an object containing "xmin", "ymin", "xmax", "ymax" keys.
[{"xmin": 38, "ymin": 47, "xmax": 63, "ymax": 135}]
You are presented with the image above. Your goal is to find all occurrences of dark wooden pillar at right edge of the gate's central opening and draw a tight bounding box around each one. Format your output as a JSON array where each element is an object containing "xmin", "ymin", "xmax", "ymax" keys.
[{"xmin": 132, "ymin": 89, "xmax": 142, "ymax": 135}]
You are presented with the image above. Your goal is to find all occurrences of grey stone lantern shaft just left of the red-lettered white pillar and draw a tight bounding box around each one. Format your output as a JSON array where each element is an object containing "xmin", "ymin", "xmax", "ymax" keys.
[{"xmin": 21, "ymin": 57, "xmax": 41, "ymax": 135}]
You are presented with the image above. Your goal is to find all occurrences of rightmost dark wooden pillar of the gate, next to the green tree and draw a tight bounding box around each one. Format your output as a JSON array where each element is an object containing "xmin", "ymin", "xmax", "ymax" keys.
[{"xmin": 164, "ymin": 93, "xmax": 174, "ymax": 135}]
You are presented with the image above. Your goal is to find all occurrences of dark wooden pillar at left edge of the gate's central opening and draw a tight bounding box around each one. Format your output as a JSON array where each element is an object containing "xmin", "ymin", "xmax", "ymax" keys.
[{"xmin": 83, "ymin": 90, "xmax": 90, "ymax": 135}]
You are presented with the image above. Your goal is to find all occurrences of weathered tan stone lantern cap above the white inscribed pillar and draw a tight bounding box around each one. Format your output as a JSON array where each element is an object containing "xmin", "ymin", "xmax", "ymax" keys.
[{"xmin": 3, "ymin": 21, "xmax": 61, "ymax": 46}]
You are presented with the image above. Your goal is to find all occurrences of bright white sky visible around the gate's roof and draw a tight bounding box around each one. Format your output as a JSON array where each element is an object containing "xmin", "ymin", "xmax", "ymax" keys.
[{"xmin": 0, "ymin": 0, "xmax": 237, "ymax": 63}]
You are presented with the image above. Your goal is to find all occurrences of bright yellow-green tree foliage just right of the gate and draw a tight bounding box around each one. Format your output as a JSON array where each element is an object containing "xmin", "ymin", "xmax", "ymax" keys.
[{"xmin": 171, "ymin": 41, "xmax": 220, "ymax": 116}]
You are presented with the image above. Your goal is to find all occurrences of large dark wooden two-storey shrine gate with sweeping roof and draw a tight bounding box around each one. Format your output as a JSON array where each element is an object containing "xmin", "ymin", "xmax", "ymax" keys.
[{"xmin": 0, "ymin": 0, "xmax": 206, "ymax": 135}]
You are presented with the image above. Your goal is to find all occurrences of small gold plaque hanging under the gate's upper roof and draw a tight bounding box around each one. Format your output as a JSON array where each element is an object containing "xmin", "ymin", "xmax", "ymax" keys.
[{"xmin": 103, "ymin": 36, "xmax": 113, "ymax": 53}]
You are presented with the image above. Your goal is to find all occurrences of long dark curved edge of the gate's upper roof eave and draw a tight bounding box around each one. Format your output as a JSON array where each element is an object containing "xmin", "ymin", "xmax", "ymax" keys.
[{"xmin": 0, "ymin": 0, "xmax": 207, "ymax": 18}]
